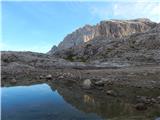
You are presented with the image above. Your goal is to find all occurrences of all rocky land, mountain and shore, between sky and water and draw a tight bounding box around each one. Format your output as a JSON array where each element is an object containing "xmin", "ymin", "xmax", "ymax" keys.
[{"xmin": 1, "ymin": 19, "xmax": 160, "ymax": 117}]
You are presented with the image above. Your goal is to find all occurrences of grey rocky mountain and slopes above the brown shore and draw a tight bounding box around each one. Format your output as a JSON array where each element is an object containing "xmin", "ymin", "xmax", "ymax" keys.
[{"xmin": 1, "ymin": 19, "xmax": 160, "ymax": 84}]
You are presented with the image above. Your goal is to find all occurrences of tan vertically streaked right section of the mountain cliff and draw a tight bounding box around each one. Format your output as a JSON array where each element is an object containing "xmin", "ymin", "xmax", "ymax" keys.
[{"xmin": 99, "ymin": 19, "xmax": 155, "ymax": 38}]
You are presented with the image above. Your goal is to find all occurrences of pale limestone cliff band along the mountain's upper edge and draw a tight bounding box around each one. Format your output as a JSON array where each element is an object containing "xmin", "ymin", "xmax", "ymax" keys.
[{"xmin": 49, "ymin": 19, "xmax": 156, "ymax": 54}]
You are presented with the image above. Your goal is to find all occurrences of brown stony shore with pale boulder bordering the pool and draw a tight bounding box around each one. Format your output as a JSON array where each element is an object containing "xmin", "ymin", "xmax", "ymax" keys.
[{"xmin": 1, "ymin": 60, "xmax": 160, "ymax": 115}]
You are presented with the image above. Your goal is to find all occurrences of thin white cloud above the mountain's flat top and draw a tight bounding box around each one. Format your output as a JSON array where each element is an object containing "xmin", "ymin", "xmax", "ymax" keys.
[{"xmin": 91, "ymin": 0, "xmax": 160, "ymax": 22}]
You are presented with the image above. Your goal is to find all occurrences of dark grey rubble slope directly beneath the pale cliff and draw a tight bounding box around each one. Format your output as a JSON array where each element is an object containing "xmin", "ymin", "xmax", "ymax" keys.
[{"xmin": 55, "ymin": 24, "xmax": 160, "ymax": 65}]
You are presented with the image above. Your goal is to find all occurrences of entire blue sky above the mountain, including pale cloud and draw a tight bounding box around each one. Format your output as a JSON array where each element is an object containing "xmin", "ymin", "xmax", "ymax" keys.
[{"xmin": 0, "ymin": 0, "xmax": 160, "ymax": 53}]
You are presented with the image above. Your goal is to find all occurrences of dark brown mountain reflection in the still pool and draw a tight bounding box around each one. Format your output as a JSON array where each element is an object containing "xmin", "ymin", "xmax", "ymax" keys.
[{"xmin": 49, "ymin": 81, "xmax": 160, "ymax": 119}]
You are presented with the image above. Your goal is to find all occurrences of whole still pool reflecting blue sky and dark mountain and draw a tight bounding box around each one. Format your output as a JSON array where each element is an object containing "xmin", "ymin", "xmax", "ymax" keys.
[{"xmin": 2, "ymin": 83, "xmax": 159, "ymax": 120}]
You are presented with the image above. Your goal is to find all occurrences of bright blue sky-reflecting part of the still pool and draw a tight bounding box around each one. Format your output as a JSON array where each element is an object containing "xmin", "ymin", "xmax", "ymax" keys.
[{"xmin": 2, "ymin": 84, "xmax": 101, "ymax": 120}]
